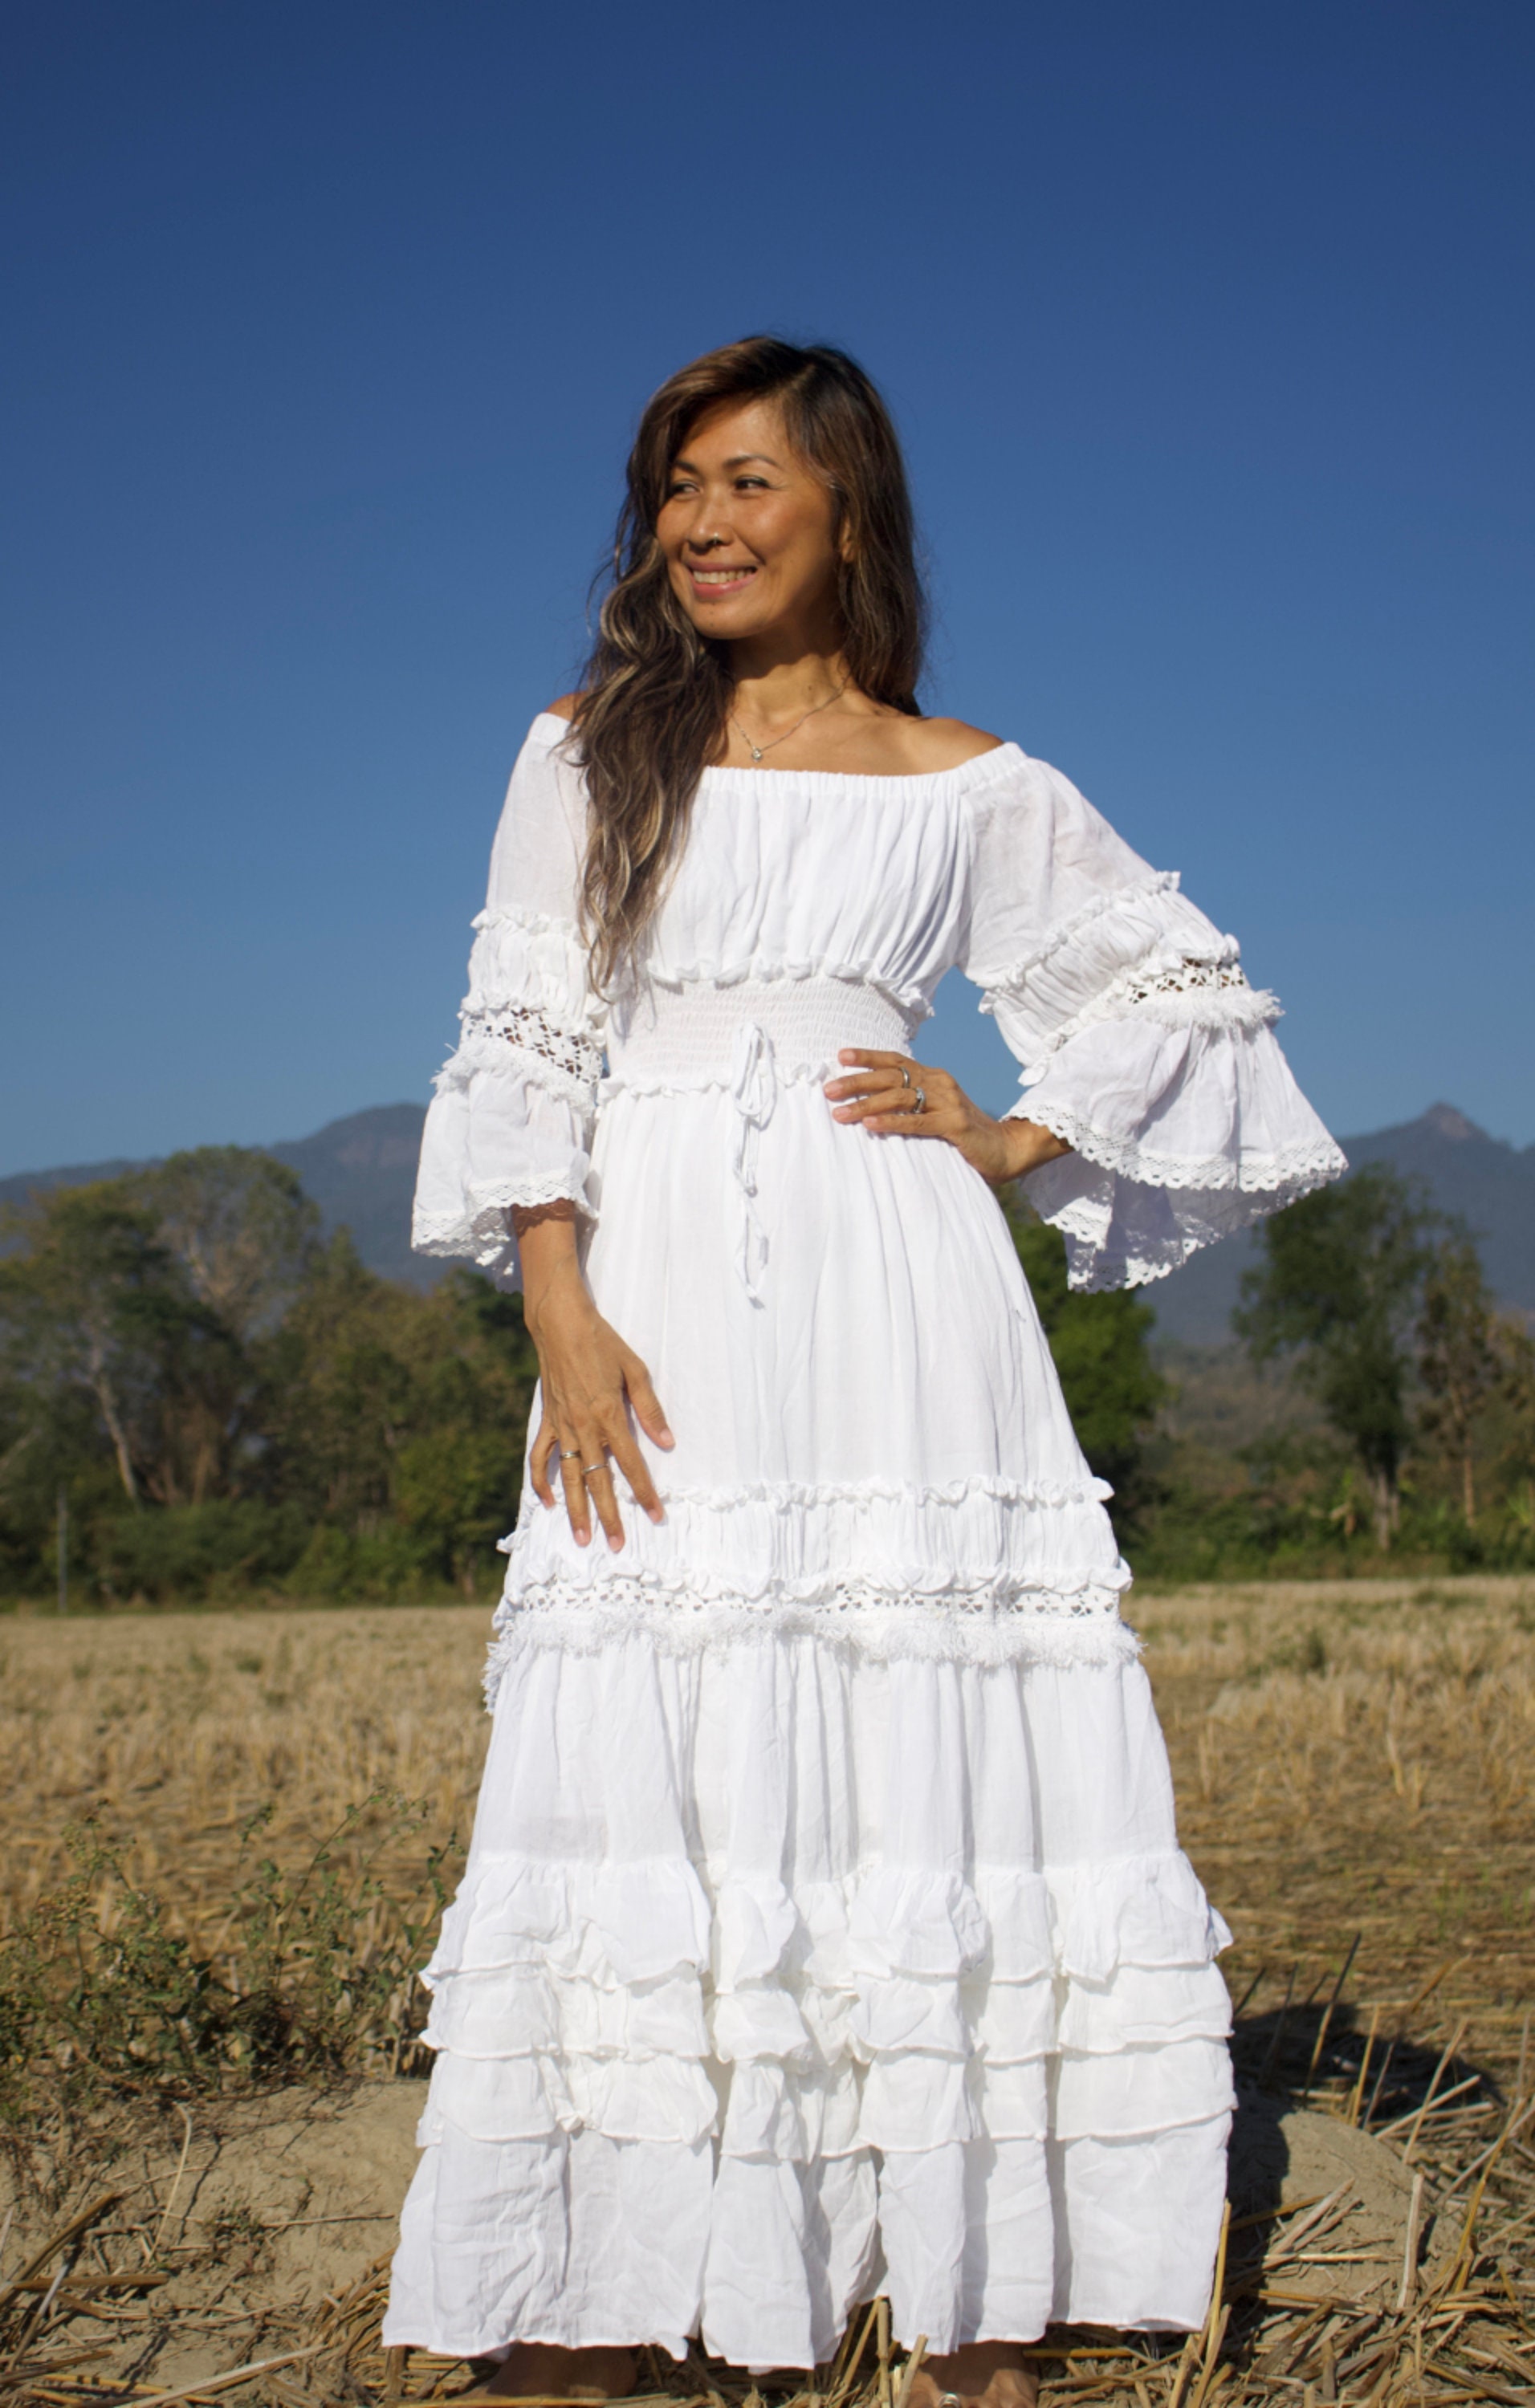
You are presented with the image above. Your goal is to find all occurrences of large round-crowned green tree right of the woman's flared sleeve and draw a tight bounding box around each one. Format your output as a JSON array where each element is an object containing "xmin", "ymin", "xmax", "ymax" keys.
[{"xmin": 1232, "ymin": 1163, "xmax": 1439, "ymax": 1548}]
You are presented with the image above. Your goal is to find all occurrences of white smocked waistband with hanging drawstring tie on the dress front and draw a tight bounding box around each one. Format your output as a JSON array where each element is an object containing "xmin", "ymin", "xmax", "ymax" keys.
[{"xmin": 597, "ymin": 978, "xmax": 928, "ymax": 1305}]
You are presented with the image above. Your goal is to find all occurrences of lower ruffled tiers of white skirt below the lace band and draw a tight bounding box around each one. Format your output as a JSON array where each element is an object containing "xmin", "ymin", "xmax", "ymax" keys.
[{"xmin": 383, "ymin": 1616, "xmax": 1232, "ymax": 2369}]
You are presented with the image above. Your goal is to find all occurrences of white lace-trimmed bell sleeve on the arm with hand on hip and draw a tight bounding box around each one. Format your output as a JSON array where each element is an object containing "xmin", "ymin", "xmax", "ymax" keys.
[{"xmin": 962, "ymin": 756, "xmax": 1347, "ymax": 1288}]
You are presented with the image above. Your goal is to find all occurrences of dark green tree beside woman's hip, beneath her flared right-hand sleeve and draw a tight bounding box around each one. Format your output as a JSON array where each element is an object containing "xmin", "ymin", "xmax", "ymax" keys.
[{"xmin": 1008, "ymin": 1202, "xmax": 1167, "ymax": 1529}]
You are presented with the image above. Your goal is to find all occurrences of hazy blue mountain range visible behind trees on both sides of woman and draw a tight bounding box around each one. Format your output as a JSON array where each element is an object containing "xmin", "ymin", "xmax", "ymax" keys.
[{"xmin": 0, "ymin": 1103, "xmax": 1535, "ymax": 1346}]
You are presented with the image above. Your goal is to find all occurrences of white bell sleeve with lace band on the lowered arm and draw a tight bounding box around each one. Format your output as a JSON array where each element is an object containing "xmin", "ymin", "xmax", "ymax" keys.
[{"xmin": 409, "ymin": 715, "xmax": 605, "ymax": 1288}]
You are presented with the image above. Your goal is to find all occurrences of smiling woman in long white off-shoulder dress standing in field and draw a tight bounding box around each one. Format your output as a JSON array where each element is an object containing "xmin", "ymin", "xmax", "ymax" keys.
[{"xmin": 385, "ymin": 337, "xmax": 1342, "ymax": 2408}]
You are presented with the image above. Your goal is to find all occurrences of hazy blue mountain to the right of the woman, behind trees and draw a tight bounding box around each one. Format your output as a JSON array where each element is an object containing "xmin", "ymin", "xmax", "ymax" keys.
[{"xmin": 1145, "ymin": 1103, "xmax": 1535, "ymax": 1346}]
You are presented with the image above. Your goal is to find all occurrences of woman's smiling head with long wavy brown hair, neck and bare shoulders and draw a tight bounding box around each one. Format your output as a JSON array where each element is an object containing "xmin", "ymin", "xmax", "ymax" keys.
[{"xmin": 568, "ymin": 340, "xmax": 996, "ymax": 980}]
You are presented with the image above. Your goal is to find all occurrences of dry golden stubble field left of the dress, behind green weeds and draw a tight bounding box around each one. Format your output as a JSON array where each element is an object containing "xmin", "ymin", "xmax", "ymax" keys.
[{"xmin": 0, "ymin": 1606, "xmax": 489, "ymax": 1953}]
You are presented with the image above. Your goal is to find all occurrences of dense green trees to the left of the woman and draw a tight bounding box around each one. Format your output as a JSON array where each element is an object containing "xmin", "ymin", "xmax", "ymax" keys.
[{"xmin": 0, "ymin": 1146, "xmax": 537, "ymax": 1604}]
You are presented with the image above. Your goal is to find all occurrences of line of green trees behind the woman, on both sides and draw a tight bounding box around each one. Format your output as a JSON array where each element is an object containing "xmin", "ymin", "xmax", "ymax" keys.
[{"xmin": 0, "ymin": 1146, "xmax": 1535, "ymax": 1606}]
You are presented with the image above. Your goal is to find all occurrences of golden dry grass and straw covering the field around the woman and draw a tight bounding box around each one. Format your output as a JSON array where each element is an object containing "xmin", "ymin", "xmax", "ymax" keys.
[{"xmin": 0, "ymin": 1577, "xmax": 1535, "ymax": 2408}]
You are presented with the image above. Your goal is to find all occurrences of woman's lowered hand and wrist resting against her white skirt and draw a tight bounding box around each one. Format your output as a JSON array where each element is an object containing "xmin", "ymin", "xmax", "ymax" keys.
[{"xmin": 513, "ymin": 1204, "xmax": 674, "ymax": 1551}]
